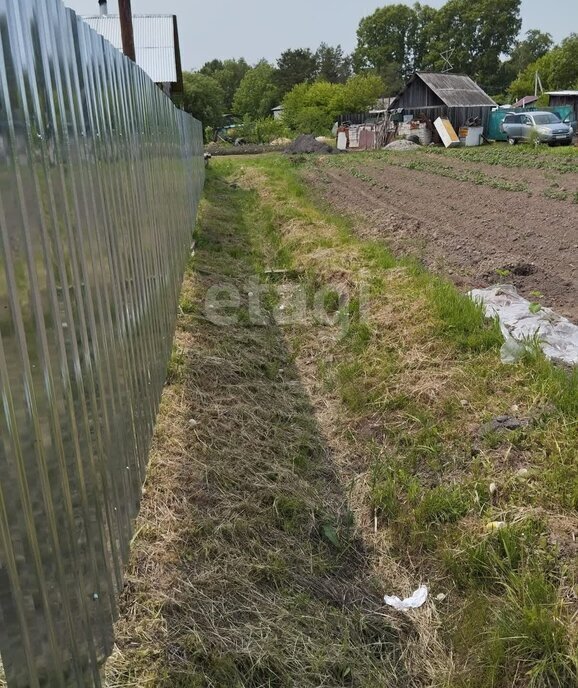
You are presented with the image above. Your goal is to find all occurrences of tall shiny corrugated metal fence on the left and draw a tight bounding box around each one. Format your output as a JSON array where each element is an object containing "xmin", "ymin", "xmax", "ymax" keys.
[{"xmin": 0, "ymin": 0, "xmax": 204, "ymax": 688}]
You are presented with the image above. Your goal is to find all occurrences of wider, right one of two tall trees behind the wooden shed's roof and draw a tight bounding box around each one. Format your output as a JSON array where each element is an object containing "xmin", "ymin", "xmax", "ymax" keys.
[{"xmin": 424, "ymin": 0, "xmax": 522, "ymax": 90}]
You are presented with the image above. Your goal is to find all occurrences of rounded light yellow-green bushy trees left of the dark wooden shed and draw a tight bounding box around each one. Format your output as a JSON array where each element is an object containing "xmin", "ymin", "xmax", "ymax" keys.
[{"xmin": 283, "ymin": 74, "xmax": 384, "ymax": 134}]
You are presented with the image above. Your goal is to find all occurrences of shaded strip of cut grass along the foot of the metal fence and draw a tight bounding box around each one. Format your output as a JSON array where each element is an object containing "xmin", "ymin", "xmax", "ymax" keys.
[{"xmin": 107, "ymin": 165, "xmax": 446, "ymax": 688}]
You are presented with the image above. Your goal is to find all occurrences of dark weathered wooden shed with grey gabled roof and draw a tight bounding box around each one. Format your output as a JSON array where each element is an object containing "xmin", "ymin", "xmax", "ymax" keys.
[{"xmin": 389, "ymin": 72, "xmax": 497, "ymax": 131}]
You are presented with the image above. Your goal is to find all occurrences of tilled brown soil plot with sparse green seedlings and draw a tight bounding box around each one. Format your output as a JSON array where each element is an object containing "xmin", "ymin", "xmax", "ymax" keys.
[{"xmin": 308, "ymin": 155, "xmax": 578, "ymax": 321}]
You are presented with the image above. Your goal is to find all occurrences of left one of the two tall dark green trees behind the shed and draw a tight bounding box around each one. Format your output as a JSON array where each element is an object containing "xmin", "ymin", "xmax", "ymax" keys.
[{"xmin": 353, "ymin": 4, "xmax": 424, "ymax": 80}]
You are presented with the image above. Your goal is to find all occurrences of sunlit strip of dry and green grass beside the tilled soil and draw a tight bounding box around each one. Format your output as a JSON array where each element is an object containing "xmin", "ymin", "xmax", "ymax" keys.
[{"xmin": 227, "ymin": 157, "xmax": 578, "ymax": 687}]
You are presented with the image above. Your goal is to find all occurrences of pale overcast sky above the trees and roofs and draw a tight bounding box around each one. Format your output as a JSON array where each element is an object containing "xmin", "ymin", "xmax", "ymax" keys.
[{"xmin": 64, "ymin": 0, "xmax": 578, "ymax": 69}]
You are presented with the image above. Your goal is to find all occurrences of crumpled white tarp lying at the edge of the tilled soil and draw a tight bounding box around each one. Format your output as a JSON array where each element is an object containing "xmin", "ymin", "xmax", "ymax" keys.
[{"xmin": 470, "ymin": 284, "xmax": 578, "ymax": 365}]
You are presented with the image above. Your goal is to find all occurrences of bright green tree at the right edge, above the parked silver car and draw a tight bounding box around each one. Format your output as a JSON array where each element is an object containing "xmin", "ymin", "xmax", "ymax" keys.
[{"xmin": 510, "ymin": 34, "xmax": 578, "ymax": 98}]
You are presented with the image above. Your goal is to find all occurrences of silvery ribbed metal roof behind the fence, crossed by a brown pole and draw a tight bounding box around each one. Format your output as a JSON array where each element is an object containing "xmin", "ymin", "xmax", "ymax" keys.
[{"xmin": 83, "ymin": 14, "xmax": 180, "ymax": 84}]
